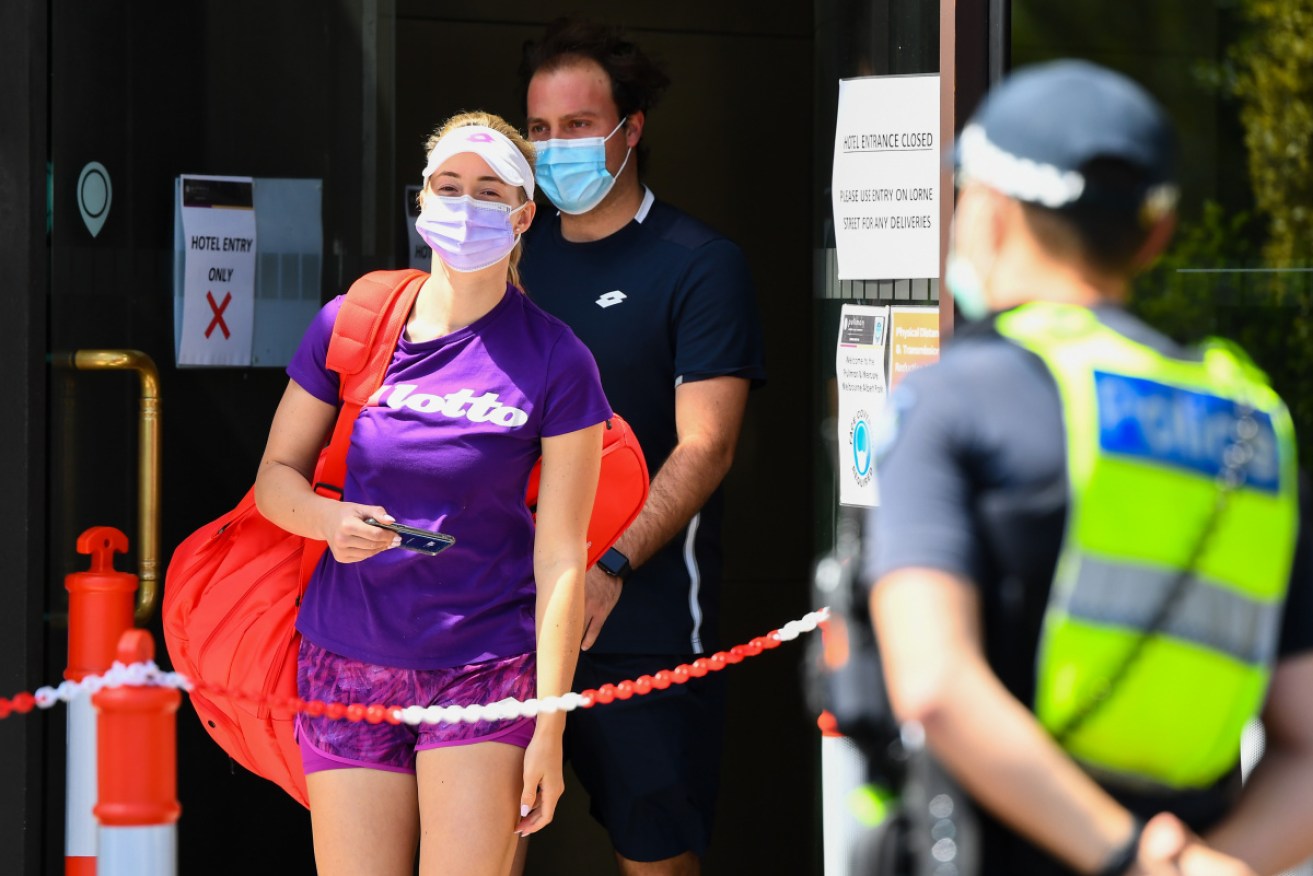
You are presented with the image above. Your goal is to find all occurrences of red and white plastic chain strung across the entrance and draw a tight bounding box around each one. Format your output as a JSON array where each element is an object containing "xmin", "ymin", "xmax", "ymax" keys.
[{"xmin": 0, "ymin": 608, "xmax": 830, "ymax": 725}]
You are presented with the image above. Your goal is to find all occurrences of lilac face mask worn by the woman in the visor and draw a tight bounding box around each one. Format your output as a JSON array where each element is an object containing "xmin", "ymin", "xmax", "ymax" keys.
[{"xmin": 415, "ymin": 194, "xmax": 528, "ymax": 272}]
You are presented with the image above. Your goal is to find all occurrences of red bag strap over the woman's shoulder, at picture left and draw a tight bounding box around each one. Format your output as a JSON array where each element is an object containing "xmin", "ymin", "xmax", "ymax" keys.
[{"xmin": 297, "ymin": 268, "xmax": 428, "ymax": 588}]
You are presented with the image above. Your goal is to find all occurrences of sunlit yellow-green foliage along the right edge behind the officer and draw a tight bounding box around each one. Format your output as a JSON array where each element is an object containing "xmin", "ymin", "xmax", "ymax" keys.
[{"xmin": 1132, "ymin": 0, "xmax": 1313, "ymax": 466}]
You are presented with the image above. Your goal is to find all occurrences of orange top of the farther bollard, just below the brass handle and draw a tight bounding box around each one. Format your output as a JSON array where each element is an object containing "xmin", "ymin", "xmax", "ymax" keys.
[{"xmin": 64, "ymin": 527, "xmax": 137, "ymax": 682}]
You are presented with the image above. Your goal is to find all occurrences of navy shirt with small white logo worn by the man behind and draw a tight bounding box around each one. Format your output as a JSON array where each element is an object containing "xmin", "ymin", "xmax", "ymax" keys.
[{"xmin": 520, "ymin": 192, "xmax": 765, "ymax": 654}]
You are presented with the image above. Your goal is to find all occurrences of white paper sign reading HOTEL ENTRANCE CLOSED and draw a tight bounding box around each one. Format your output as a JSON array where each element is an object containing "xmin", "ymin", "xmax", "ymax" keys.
[{"xmin": 831, "ymin": 75, "xmax": 940, "ymax": 280}]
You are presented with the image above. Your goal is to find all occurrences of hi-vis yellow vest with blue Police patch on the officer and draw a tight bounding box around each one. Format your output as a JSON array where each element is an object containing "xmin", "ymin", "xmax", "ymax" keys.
[{"xmin": 997, "ymin": 302, "xmax": 1297, "ymax": 788}]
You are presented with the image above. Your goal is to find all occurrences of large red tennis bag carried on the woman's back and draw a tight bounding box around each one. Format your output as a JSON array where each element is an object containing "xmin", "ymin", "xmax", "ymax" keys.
[{"xmin": 161, "ymin": 271, "xmax": 649, "ymax": 806}]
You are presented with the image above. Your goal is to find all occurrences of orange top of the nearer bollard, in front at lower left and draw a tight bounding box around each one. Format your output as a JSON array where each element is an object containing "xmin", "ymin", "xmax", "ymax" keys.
[{"xmin": 92, "ymin": 629, "xmax": 183, "ymax": 829}]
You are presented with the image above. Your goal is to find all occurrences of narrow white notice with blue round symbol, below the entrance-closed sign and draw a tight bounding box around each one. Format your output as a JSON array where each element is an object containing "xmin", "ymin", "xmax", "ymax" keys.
[{"xmin": 834, "ymin": 305, "xmax": 889, "ymax": 507}]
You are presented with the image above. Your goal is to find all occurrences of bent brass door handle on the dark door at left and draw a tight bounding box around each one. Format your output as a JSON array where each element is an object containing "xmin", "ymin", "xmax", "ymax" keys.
[{"xmin": 72, "ymin": 349, "xmax": 160, "ymax": 625}]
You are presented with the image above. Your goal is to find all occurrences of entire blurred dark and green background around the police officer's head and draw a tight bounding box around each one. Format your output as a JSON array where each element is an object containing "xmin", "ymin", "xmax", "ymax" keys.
[{"xmin": 1011, "ymin": 0, "xmax": 1313, "ymax": 468}]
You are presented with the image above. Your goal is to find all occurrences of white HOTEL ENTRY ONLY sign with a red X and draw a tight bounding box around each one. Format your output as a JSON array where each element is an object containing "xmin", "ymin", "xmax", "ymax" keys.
[{"xmin": 175, "ymin": 176, "xmax": 256, "ymax": 366}]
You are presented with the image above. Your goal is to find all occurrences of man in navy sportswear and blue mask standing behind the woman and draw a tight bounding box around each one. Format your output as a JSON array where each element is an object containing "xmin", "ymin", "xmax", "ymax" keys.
[{"xmin": 521, "ymin": 15, "xmax": 765, "ymax": 876}]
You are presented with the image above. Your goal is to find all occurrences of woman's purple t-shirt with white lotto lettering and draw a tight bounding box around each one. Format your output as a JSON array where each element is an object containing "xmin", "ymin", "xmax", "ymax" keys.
[{"xmin": 288, "ymin": 286, "xmax": 611, "ymax": 668}]
